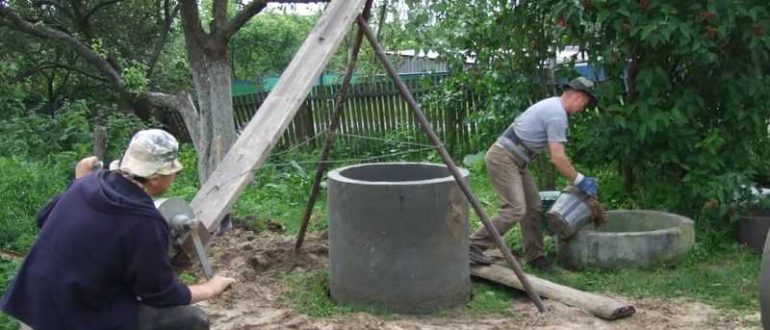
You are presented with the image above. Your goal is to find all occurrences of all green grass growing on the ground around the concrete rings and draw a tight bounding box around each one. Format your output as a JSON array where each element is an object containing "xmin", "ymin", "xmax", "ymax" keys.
[{"xmin": 0, "ymin": 147, "xmax": 761, "ymax": 324}]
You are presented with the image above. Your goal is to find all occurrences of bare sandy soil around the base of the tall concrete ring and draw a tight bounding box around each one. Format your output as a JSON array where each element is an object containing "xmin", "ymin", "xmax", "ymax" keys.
[{"xmin": 192, "ymin": 228, "xmax": 759, "ymax": 330}]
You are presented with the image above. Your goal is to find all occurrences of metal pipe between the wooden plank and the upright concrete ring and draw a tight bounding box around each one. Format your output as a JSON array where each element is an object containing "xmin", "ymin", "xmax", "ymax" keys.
[{"xmin": 294, "ymin": 0, "xmax": 373, "ymax": 253}]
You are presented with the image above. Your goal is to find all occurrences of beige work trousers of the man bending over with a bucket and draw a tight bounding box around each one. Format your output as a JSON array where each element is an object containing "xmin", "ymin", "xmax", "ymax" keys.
[{"xmin": 470, "ymin": 145, "xmax": 543, "ymax": 261}]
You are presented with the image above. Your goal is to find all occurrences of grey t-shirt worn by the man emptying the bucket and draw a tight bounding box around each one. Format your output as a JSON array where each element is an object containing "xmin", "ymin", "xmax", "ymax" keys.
[{"xmin": 511, "ymin": 96, "xmax": 568, "ymax": 151}]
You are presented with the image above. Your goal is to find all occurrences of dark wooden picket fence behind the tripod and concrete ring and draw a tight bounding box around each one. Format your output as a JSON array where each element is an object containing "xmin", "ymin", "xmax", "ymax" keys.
[{"xmin": 163, "ymin": 75, "xmax": 479, "ymax": 157}]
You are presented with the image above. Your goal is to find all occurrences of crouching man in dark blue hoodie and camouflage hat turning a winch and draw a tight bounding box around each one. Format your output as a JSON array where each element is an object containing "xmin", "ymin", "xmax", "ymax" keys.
[{"xmin": 0, "ymin": 129, "xmax": 235, "ymax": 330}]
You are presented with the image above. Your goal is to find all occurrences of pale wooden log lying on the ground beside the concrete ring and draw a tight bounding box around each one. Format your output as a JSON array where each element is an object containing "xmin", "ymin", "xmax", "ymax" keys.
[{"xmin": 471, "ymin": 264, "xmax": 636, "ymax": 320}]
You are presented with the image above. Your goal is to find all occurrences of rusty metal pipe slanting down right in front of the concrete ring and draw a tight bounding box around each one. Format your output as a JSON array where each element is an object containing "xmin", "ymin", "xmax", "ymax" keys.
[{"xmin": 358, "ymin": 16, "xmax": 545, "ymax": 312}]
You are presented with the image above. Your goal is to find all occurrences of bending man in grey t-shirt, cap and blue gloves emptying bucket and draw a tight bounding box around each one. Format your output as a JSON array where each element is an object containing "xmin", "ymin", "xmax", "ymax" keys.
[{"xmin": 470, "ymin": 77, "xmax": 598, "ymax": 271}]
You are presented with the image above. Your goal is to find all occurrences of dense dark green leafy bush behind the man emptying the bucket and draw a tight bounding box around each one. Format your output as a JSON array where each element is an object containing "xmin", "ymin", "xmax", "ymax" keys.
[{"xmin": 553, "ymin": 1, "xmax": 770, "ymax": 237}]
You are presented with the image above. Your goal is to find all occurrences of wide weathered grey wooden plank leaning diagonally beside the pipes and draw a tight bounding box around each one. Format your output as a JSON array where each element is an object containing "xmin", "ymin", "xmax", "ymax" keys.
[{"xmin": 190, "ymin": 0, "xmax": 365, "ymax": 237}]
